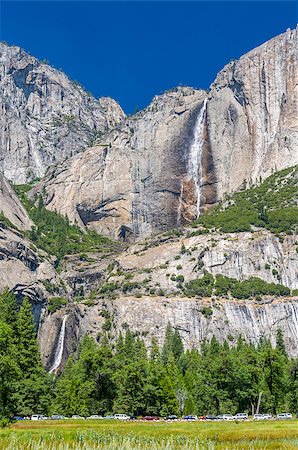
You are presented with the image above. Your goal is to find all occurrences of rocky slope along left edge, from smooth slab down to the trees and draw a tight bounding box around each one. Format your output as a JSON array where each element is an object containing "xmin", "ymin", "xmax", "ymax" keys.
[{"xmin": 0, "ymin": 174, "xmax": 65, "ymax": 325}]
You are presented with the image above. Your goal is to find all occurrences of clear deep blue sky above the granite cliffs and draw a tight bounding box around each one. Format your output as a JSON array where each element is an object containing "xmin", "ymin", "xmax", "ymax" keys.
[{"xmin": 0, "ymin": 0, "xmax": 297, "ymax": 113}]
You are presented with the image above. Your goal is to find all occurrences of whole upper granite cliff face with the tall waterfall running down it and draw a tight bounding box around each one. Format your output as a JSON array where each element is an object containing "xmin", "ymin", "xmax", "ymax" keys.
[{"xmin": 32, "ymin": 29, "xmax": 298, "ymax": 239}]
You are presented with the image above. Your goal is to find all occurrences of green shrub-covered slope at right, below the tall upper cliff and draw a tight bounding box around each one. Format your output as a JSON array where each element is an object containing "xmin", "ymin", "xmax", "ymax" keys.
[{"xmin": 194, "ymin": 166, "xmax": 298, "ymax": 234}]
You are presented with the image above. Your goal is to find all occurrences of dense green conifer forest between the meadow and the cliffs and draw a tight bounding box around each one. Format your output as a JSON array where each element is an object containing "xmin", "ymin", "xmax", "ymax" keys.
[{"xmin": 0, "ymin": 290, "xmax": 298, "ymax": 420}]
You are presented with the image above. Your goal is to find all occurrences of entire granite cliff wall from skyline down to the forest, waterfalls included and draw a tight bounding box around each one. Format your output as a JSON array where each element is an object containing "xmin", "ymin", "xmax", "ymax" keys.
[{"xmin": 0, "ymin": 29, "xmax": 298, "ymax": 369}]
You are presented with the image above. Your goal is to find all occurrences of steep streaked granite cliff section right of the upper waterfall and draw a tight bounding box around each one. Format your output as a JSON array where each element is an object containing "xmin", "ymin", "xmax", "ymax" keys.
[{"xmin": 203, "ymin": 27, "xmax": 298, "ymax": 205}]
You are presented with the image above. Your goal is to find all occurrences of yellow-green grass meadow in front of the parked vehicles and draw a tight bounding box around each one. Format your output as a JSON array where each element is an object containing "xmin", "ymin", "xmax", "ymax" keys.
[{"xmin": 0, "ymin": 420, "xmax": 298, "ymax": 450}]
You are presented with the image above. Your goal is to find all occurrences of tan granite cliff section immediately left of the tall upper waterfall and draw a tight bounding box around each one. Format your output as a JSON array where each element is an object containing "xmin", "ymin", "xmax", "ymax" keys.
[{"xmin": 31, "ymin": 88, "xmax": 206, "ymax": 237}]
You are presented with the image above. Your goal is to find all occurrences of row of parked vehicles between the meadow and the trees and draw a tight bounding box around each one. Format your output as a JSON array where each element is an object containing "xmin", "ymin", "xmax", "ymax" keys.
[{"xmin": 20, "ymin": 413, "xmax": 298, "ymax": 422}]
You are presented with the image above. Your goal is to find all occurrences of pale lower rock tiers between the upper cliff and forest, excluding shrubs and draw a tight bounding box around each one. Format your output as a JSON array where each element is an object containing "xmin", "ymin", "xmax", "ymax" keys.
[{"xmin": 39, "ymin": 231, "xmax": 298, "ymax": 368}]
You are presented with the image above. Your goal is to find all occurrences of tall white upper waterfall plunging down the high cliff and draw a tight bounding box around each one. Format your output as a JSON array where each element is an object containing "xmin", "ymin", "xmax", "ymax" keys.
[{"xmin": 187, "ymin": 98, "xmax": 207, "ymax": 217}]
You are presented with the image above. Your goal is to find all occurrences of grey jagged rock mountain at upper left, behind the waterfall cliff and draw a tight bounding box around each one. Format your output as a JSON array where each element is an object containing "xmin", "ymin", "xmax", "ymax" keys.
[{"xmin": 0, "ymin": 43, "xmax": 124, "ymax": 183}]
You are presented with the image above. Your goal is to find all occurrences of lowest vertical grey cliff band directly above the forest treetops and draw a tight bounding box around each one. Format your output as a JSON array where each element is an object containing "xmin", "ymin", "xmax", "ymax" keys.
[{"xmin": 39, "ymin": 297, "xmax": 298, "ymax": 368}]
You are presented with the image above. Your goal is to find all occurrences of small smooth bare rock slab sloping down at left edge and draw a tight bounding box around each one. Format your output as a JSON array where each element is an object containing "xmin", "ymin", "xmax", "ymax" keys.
[{"xmin": 0, "ymin": 174, "xmax": 32, "ymax": 230}]
